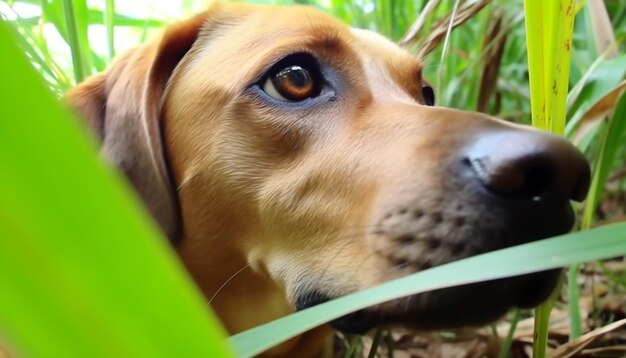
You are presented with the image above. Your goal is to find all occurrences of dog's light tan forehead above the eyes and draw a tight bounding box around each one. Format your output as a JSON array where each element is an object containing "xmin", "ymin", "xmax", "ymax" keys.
[{"xmin": 183, "ymin": 4, "xmax": 421, "ymax": 96}]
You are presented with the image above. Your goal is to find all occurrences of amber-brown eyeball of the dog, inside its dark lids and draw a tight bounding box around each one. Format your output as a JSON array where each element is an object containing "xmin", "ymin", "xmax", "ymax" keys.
[{"xmin": 263, "ymin": 65, "xmax": 316, "ymax": 102}]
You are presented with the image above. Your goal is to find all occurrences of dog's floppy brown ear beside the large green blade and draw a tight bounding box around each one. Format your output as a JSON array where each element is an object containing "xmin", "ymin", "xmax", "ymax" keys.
[{"xmin": 66, "ymin": 13, "xmax": 208, "ymax": 239}]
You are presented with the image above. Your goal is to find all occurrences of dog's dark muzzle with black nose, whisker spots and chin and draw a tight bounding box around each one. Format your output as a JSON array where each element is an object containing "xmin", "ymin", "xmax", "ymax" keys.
[{"xmin": 296, "ymin": 128, "xmax": 590, "ymax": 333}]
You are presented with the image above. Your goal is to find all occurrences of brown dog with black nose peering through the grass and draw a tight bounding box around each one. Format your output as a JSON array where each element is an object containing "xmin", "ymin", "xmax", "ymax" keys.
[{"xmin": 68, "ymin": 4, "xmax": 589, "ymax": 357}]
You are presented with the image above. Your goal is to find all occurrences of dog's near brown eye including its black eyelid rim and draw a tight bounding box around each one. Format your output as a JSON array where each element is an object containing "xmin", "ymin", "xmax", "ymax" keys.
[{"xmin": 262, "ymin": 54, "xmax": 320, "ymax": 102}]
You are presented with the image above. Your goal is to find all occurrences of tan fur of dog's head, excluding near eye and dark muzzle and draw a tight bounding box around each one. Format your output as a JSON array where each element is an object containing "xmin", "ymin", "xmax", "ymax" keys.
[{"xmin": 68, "ymin": 4, "xmax": 584, "ymax": 357}]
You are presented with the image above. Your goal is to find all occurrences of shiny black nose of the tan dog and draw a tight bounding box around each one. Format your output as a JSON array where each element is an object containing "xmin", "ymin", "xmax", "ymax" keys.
[{"xmin": 464, "ymin": 130, "xmax": 590, "ymax": 201}]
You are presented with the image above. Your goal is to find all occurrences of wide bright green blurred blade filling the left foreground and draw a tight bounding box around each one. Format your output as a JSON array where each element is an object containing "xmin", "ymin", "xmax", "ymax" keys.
[{"xmin": 0, "ymin": 21, "xmax": 232, "ymax": 358}]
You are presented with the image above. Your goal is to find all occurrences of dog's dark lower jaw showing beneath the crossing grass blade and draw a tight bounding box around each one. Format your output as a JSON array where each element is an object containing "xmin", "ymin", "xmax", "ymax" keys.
[{"xmin": 296, "ymin": 270, "xmax": 561, "ymax": 334}]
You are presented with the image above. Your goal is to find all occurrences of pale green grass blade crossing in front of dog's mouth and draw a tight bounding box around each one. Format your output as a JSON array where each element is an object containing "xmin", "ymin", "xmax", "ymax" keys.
[{"xmin": 230, "ymin": 223, "xmax": 626, "ymax": 357}]
